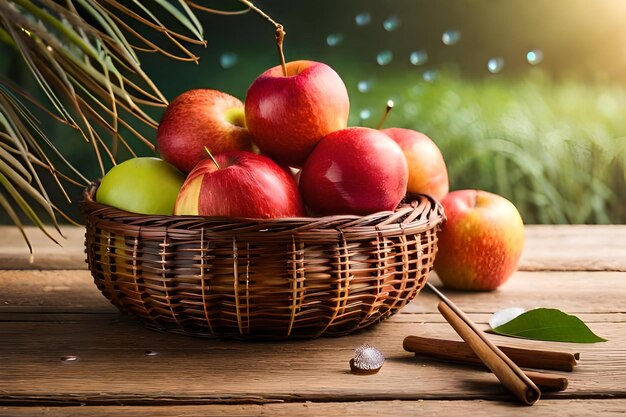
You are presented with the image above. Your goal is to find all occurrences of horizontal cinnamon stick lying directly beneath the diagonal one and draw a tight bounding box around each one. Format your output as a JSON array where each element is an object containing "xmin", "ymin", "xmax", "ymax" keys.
[{"xmin": 402, "ymin": 336, "xmax": 577, "ymax": 372}]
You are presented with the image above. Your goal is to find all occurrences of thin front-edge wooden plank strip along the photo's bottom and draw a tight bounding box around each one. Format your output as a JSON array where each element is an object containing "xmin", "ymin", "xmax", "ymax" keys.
[{"xmin": 0, "ymin": 399, "xmax": 626, "ymax": 417}]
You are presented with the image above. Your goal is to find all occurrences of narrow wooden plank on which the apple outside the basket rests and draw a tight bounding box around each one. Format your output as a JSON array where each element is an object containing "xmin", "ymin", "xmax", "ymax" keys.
[{"xmin": 0, "ymin": 270, "xmax": 626, "ymax": 314}]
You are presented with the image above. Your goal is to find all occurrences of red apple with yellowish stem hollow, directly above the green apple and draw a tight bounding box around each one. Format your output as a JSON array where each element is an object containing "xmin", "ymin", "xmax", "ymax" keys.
[{"xmin": 157, "ymin": 89, "xmax": 252, "ymax": 172}]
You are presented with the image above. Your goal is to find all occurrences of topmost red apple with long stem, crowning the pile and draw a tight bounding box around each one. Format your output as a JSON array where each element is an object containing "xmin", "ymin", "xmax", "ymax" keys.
[{"xmin": 245, "ymin": 61, "xmax": 350, "ymax": 167}]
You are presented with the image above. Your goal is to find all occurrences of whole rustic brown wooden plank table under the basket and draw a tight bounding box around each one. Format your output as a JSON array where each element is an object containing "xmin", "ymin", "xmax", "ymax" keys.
[{"xmin": 0, "ymin": 226, "xmax": 626, "ymax": 416}]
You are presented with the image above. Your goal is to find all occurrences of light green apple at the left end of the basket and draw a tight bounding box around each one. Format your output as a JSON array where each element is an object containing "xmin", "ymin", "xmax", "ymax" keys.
[{"xmin": 96, "ymin": 157, "xmax": 185, "ymax": 215}]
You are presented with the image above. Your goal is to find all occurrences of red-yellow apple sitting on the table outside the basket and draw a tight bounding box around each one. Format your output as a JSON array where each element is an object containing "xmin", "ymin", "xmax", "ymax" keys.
[{"xmin": 435, "ymin": 190, "xmax": 524, "ymax": 291}]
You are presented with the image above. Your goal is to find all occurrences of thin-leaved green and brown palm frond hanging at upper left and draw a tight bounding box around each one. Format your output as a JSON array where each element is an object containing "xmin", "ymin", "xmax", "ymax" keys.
[{"xmin": 0, "ymin": 0, "xmax": 254, "ymax": 247}]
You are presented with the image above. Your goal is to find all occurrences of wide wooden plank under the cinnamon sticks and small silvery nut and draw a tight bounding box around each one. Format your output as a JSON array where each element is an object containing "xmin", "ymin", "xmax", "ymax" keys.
[{"xmin": 0, "ymin": 315, "xmax": 626, "ymax": 405}]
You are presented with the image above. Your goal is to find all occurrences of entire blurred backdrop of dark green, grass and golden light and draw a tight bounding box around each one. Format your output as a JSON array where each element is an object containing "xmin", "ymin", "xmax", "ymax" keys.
[{"xmin": 0, "ymin": 0, "xmax": 626, "ymax": 229}]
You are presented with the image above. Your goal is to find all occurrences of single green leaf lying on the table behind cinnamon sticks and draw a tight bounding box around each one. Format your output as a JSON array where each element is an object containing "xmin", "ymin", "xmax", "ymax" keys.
[{"xmin": 491, "ymin": 308, "xmax": 606, "ymax": 343}]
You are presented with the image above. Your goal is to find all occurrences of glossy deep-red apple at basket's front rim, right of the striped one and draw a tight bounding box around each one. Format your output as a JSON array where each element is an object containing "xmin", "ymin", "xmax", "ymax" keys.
[{"xmin": 300, "ymin": 127, "xmax": 408, "ymax": 215}]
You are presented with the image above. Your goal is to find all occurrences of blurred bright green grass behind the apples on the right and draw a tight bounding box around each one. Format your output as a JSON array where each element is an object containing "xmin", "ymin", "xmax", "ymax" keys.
[{"xmin": 342, "ymin": 71, "xmax": 626, "ymax": 224}]
